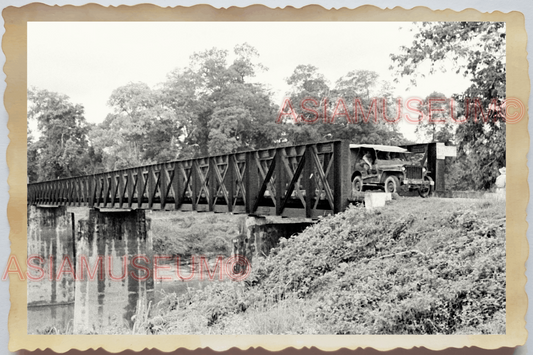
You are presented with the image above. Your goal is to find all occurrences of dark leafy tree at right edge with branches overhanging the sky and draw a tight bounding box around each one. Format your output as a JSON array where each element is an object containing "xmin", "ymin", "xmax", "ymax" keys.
[{"xmin": 391, "ymin": 22, "xmax": 506, "ymax": 189}]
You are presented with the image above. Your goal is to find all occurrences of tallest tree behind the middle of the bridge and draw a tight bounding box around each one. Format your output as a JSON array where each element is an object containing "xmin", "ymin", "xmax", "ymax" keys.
[{"xmin": 163, "ymin": 43, "xmax": 278, "ymax": 156}]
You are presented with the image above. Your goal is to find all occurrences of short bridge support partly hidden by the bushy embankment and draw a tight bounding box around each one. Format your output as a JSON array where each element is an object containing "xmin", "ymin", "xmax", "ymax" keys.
[{"xmin": 233, "ymin": 216, "xmax": 315, "ymax": 263}]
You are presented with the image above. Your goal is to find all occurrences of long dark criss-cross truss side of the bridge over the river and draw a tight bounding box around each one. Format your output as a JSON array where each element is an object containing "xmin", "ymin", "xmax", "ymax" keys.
[{"xmin": 28, "ymin": 141, "xmax": 351, "ymax": 218}]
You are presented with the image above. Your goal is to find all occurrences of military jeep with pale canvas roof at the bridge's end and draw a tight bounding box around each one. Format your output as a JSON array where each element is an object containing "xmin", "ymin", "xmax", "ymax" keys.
[{"xmin": 350, "ymin": 144, "xmax": 435, "ymax": 197}]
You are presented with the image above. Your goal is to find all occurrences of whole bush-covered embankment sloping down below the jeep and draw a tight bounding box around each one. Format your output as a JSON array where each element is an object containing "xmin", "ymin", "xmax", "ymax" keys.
[{"xmin": 147, "ymin": 199, "xmax": 506, "ymax": 334}]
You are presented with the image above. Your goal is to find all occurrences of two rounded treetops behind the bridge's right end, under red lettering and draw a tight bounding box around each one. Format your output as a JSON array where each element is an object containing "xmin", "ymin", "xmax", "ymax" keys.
[{"xmin": 282, "ymin": 65, "xmax": 405, "ymax": 144}]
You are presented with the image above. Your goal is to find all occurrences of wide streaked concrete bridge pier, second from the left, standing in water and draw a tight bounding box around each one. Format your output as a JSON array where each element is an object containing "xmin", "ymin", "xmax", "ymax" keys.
[{"xmin": 74, "ymin": 209, "xmax": 154, "ymax": 334}]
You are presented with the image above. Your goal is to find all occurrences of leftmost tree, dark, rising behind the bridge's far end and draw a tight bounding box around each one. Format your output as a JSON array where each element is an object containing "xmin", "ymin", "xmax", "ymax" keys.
[{"xmin": 28, "ymin": 88, "xmax": 91, "ymax": 181}]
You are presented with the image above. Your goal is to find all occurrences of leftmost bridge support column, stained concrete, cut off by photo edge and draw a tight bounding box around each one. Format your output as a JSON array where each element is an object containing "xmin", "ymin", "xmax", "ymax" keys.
[{"xmin": 27, "ymin": 206, "xmax": 75, "ymax": 334}]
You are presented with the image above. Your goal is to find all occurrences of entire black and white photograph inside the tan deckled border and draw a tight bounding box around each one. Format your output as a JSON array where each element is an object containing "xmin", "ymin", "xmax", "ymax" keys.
[{"xmin": 23, "ymin": 21, "xmax": 508, "ymax": 335}]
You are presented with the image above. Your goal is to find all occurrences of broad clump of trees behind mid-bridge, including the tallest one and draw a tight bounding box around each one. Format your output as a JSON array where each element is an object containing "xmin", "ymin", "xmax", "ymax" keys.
[{"xmin": 90, "ymin": 43, "xmax": 279, "ymax": 170}]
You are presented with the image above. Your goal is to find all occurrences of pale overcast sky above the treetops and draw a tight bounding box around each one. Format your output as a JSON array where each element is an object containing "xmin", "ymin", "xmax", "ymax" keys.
[{"xmin": 28, "ymin": 22, "xmax": 470, "ymax": 142}]
